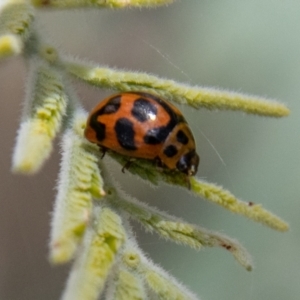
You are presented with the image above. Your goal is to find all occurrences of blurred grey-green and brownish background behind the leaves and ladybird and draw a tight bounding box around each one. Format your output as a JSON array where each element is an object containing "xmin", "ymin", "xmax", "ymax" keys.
[{"xmin": 0, "ymin": 0, "xmax": 300, "ymax": 300}]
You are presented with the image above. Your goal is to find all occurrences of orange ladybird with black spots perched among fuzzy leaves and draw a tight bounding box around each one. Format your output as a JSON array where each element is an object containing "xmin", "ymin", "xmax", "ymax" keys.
[{"xmin": 84, "ymin": 92, "xmax": 199, "ymax": 176}]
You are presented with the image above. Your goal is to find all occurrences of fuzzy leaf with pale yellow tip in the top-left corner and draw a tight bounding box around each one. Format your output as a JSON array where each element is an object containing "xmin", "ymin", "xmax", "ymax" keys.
[{"xmin": 0, "ymin": 0, "xmax": 34, "ymax": 58}]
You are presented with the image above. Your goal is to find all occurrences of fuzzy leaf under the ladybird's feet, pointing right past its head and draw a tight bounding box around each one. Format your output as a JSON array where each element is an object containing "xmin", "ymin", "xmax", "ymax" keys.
[{"xmin": 109, "ymin": 152, "xmax": 289, "ymax": 231}]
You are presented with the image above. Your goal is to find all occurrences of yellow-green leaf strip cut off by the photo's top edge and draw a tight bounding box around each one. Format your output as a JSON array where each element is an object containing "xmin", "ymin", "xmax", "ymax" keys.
[{"xmin": 31, "ymin": 0, "xmax": 174, "ymax": 8}]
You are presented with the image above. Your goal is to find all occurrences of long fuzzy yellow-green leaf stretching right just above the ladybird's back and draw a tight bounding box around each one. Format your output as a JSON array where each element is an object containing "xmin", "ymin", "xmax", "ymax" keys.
[{"xmin": 66, "ymin": 62, "xmax": 290, "ymax": 117}]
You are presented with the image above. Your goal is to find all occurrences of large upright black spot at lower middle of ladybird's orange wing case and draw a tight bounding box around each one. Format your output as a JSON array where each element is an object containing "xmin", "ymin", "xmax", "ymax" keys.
[{"xmin": 115, "ymin": 118, "xmax": 137, "ymax": 150}]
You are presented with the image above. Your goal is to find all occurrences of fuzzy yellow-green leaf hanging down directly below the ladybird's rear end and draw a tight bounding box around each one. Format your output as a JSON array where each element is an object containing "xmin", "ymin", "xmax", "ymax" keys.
[{"xmin": 50, "ymin": 110, "xmax": 105, "ymax": 264}]
